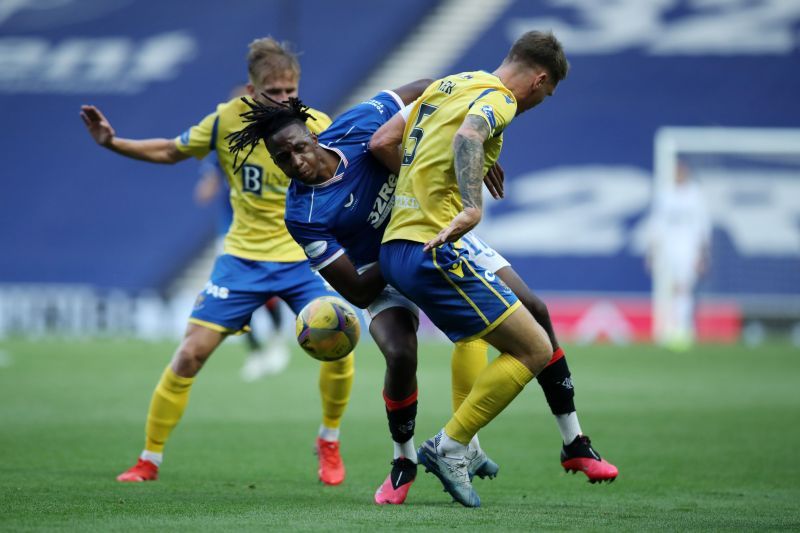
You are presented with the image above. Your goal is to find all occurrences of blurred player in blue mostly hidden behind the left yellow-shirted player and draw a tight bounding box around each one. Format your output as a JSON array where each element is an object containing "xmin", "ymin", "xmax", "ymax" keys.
[{"xmin": 194, "ymin": 106, "xmax": 291, "ymax": 382}]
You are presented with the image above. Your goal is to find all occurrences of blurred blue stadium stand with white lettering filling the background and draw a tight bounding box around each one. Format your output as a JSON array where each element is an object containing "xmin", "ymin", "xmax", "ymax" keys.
[{"xmin": 0, "ymin": 0, "xmax": 800, "ymax": 339}]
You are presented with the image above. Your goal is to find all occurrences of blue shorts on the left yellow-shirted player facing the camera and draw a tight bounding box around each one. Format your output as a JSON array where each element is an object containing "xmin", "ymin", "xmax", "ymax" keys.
[{"xmin": 189, "ymin": 254, "xmax": 333, "ymax": 333}]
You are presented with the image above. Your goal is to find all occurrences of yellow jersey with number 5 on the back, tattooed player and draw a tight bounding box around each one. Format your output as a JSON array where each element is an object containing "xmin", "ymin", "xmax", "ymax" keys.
[{"xmin": 383, "ymin": 71, "xmax": 517, "ymax": 242}]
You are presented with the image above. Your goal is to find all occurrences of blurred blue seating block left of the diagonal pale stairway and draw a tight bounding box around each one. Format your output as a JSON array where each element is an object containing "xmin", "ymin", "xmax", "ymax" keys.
[{"xmin": 0, "ymin": 0, "xmax": 435, "ymax": 290}]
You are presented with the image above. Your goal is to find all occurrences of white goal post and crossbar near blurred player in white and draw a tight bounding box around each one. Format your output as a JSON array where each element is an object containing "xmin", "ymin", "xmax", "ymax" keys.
[{"xmin": 653, "ymin": 127, "xmax": 800, "ymax": 342}]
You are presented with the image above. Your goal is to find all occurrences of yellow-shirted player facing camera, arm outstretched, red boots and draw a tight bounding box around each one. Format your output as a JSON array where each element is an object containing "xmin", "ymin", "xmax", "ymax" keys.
[{"xmin": 81, "ymin": 38, "xmax": 353, "ymax": 485}]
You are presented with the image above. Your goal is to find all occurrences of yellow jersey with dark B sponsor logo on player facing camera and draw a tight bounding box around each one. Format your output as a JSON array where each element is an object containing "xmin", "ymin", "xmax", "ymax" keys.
[{"xmin": 175, "ymin": 97, "xmax": 331, "ymax": 263}]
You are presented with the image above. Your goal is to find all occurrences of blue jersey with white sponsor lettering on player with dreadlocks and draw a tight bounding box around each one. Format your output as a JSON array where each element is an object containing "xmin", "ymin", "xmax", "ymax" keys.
[{"xmin": 285, "ymin": 91, "xmax": 403, "ymax": 270}]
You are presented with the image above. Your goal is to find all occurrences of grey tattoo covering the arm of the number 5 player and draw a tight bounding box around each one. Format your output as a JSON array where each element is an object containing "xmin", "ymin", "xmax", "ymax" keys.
[{"xmin": 453, "ymin": 115, "xmax": 490, "ymax": 209}]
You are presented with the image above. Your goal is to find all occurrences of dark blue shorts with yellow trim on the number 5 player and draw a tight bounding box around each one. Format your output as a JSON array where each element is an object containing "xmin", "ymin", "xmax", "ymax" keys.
[{"xmin": 380, "ymin": 240, "xmax": 520, "ymax": 342}]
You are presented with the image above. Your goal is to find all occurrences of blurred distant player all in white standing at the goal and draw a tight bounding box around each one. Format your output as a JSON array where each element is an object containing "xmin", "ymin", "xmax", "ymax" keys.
[{"xmin": 646, "ymin": 162, "xmax": 711, "ymax": 351}]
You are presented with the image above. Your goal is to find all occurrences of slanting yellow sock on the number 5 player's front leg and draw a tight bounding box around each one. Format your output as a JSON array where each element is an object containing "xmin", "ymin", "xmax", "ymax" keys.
[{"xmin": 444, "ymin": 353, "xmax": 533, "ymax": 445}]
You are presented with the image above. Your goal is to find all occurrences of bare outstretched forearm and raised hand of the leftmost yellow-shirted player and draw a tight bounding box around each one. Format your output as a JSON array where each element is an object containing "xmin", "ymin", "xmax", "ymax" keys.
[{"xmin": 81, "ymin": 105, "xmax": 189, "ymax": 164}]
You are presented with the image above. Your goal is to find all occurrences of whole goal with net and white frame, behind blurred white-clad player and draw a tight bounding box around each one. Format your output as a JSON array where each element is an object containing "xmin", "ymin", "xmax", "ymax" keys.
[{"xmin": 652, "ymin": 127, "xmax": 800, "ymax": 342}]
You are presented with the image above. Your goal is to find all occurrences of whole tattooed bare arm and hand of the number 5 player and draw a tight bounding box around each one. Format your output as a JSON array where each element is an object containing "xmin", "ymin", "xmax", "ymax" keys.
[{"xmin": 423, "ymin": 115, "xmax": 491, "ymax": 251}]
